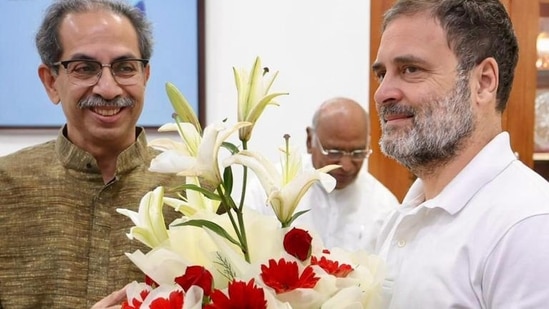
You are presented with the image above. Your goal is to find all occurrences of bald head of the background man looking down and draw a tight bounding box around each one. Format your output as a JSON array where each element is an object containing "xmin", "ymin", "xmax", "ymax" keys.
[{"xmin": 307, "ymin": 97, "xmax": 369, "ymax": 189}]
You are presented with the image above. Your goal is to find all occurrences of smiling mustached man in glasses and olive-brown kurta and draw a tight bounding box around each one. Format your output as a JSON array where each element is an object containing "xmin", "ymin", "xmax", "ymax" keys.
[{"xmin": 0, "ymin": 0, "xmax": 178, "ymax": 309}]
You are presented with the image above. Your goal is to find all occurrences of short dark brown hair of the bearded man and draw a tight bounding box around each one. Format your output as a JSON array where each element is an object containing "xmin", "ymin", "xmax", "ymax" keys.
[{"xmin": 382, "ymin": 0, "xmax": 519, "ymax": 112}]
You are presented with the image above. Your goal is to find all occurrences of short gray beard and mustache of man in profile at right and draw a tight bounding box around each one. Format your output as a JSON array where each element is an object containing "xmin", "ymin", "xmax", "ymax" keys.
[{"xmin": 379, "ymin": 76, "xmax": 475, "ymax": 175}]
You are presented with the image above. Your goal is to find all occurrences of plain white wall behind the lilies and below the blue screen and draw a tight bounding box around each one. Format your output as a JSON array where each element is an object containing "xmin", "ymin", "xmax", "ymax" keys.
[{"xmin": 0, "ymin": 0, "xmax": 370, "ymax": 159}]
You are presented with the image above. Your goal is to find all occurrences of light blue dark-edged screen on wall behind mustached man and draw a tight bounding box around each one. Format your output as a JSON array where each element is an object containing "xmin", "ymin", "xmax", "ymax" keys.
[{"xmin": 0, "ymin": 0, "xmax": 204, "ymax": 128}]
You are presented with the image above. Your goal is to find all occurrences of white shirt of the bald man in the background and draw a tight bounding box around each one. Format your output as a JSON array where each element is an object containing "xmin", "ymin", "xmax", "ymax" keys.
[{"xmin": 246, "ymin": 156, "xmax": 399, "ymax": 252}]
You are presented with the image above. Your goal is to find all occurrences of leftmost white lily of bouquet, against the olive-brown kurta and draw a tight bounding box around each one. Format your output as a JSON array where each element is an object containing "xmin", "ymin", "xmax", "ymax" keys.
[{"xmin": 116, "ymin": 187, "xmax": 168, "ymax": 248}]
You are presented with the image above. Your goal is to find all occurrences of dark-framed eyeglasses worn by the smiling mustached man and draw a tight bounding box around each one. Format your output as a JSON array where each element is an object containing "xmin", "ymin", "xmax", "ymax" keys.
[{"xmin": 53, "ymin": 59, "xmax": 149, "ymax": 86}]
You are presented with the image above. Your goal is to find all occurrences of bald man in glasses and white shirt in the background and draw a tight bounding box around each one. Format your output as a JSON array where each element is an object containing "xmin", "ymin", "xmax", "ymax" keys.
[{"xmin": 246, "ymin": 97, "xmax": 399, "ymax": 252}]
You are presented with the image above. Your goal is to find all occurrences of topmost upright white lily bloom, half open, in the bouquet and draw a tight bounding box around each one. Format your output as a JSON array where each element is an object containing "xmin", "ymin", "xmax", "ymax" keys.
[{"xmin": 233, "ymin": 57, "xmax": 288, "ymax": 141}]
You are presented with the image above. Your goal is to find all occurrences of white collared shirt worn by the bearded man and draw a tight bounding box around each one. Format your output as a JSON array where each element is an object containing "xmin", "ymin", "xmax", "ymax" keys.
[{"xmin": 376, "ymin": 132, "xmax": 549, "ymax": 309}]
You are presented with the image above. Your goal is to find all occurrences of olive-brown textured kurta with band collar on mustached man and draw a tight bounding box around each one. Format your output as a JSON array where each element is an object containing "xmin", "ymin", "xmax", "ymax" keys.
[{"xmin": 0, "ymin": 129, "xmax": 182, "ymax": 309}]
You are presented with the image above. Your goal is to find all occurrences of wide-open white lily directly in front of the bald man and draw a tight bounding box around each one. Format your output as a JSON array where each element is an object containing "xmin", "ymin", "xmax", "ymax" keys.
[{"xmin": 223, "ymin": 144, "xmax": 339, "ymax": 227}]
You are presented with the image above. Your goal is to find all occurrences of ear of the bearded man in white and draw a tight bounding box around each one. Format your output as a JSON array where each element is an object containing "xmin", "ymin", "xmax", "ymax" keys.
[{"xmin": 473, "ymin": 57, "xmax": 499, "ymax": 105}]
